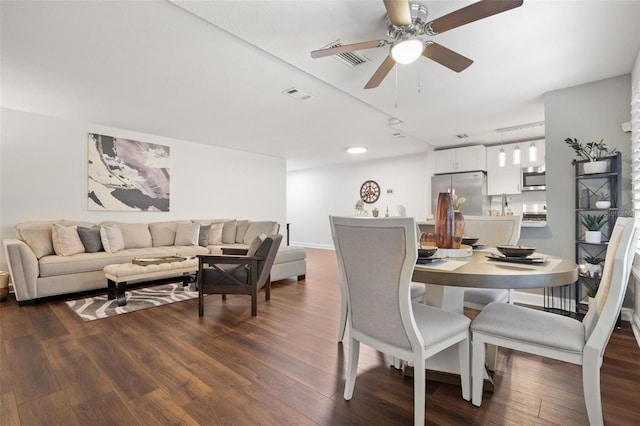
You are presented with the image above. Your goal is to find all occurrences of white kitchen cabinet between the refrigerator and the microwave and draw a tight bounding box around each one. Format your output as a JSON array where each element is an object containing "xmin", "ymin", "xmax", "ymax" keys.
[{"xmin": 487, "ymin": 144, "xmax": 523, "ymax": 195}]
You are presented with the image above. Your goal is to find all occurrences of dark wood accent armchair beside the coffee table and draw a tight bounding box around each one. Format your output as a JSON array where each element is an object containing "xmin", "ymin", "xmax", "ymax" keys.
[{"xmin": 198, "ymin": 234, "xmax": 282, "ymax": 317}]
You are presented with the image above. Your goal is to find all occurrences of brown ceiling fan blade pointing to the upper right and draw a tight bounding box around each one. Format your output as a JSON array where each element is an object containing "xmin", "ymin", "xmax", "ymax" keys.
[{"xmin": 424, "ymin": 0, "xmax": 523, "ymax": 35}]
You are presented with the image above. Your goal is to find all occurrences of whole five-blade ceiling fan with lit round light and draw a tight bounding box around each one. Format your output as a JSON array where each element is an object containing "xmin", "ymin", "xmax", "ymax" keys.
[{"xmin": 311, "ymin": 0, "xmax": 523, "ymax": 89}]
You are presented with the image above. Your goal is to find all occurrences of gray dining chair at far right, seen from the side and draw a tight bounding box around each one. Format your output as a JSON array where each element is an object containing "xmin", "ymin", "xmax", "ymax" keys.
[{"xmin": 471, "ymin": 218, "xmax": 640, "ymax": 426}]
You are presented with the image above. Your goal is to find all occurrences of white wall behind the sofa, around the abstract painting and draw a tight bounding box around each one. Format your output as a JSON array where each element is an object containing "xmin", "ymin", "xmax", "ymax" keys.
[{"xmin": 0, "ymin": 109, "xmax": 286, "ymax": 269}]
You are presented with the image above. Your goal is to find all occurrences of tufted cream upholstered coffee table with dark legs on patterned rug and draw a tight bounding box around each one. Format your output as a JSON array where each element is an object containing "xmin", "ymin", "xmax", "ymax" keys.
[{"xmin": 104, "ymin": 257, "xmax": 198, "ymax": 306}]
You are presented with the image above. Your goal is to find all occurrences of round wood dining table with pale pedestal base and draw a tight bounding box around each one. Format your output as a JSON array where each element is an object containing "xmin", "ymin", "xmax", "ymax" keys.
[{"xmin": 412, "ymin": 247, "xmax": 578, "ymax": 391}]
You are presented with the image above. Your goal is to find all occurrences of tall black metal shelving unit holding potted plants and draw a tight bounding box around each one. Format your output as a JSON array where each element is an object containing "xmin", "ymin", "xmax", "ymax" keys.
[{"xmin": 574, "ymin": 153, "xmax": 622, "ymax": 314}]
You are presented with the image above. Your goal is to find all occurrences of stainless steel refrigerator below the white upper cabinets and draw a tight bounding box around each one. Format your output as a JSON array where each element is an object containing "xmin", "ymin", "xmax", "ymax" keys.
[{"xmin": 431, "ymin": 171, "xmax": 491, "ymax": 216}]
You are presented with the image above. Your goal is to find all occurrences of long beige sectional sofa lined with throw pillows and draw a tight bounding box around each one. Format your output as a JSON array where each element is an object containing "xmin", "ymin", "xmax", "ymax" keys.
[{"xmin": 3, "ymin": 219, "xmax": 306, "ymax": 305}]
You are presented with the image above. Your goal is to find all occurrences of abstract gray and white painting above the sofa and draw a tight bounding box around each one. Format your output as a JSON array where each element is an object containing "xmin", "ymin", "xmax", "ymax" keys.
[{"xmin": 87, "ymin": 133, "xmax": 170, "ymax": 212}]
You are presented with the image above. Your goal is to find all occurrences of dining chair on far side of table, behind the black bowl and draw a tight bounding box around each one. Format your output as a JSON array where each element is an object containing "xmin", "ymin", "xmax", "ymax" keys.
[{"xmin": 464, "ymin": 215, "xmax": 522, "ymax": 309}]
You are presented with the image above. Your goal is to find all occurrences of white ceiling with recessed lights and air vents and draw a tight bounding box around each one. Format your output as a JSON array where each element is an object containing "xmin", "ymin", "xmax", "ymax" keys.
[{"xmin": 0, "ymin": 0, "xmax": 640, "ymax": 170}]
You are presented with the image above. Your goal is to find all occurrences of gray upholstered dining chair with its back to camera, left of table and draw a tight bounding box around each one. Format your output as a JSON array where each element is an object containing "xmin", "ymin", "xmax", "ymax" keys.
[{"xmin": 329, "ymin": 216, "xmax": 470, "ymax": 425}]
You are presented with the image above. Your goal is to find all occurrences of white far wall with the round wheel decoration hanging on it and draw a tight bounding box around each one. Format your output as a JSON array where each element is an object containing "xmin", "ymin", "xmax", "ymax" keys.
[{"xmin": 287, "ymin": 153, "xmax": 433, "ymax": 248}]
